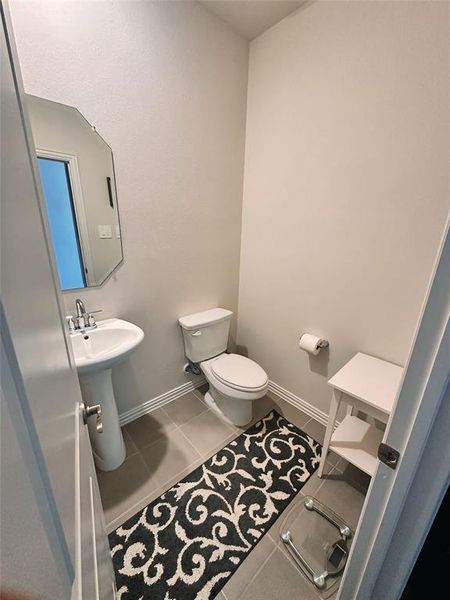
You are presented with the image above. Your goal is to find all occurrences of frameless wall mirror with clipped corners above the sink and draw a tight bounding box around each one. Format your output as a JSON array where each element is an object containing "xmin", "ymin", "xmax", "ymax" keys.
[{"xmin": 27, "ymin": 96, "xmax": 123, "ymax": 290}]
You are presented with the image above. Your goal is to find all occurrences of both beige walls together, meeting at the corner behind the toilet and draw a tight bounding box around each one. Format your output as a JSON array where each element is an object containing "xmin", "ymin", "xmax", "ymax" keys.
[{"xmin": 12, "ymin": 0, "xmax": 449, "ymax": 422}]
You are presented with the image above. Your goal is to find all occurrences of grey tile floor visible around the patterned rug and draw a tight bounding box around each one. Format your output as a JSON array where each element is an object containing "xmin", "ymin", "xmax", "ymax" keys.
[{"xmin": 98, "ymin": 386, "xmax": 369, "ymax": 600}]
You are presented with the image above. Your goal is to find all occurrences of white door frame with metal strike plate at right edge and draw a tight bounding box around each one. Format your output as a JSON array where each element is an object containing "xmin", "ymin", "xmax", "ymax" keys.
[{"xmin": 337, "ymin": 220, "xmax": 450, "ymax": 600}]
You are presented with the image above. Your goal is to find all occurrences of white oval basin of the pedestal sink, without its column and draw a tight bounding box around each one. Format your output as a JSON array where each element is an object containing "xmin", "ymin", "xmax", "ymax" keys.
[{"xmin": 70, "ymin": 319, "xmax": 144, "ymax": 375}]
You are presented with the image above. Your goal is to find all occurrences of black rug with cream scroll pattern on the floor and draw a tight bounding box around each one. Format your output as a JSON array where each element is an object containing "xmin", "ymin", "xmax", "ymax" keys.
[{"xmin": 109, "ymin": 411, "xmax": 321, "ymax": 600}]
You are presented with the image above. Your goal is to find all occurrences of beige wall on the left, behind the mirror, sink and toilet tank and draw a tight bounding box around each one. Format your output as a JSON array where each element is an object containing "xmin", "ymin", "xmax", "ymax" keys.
[{"xmin": 11, "ymin": 0, "xmax": 248, "ymax": 411}]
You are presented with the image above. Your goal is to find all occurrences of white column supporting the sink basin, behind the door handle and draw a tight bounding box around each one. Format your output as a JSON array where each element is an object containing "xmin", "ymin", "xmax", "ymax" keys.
[{"xmin": 79, "ymin": 369, "xmax": 126, "ymax": 471}]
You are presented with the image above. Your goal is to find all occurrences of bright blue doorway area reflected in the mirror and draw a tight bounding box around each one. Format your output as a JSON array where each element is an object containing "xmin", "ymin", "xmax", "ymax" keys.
[{"xmin": 38, "ymin": 157, "xmax": 86, "ymax": 290}]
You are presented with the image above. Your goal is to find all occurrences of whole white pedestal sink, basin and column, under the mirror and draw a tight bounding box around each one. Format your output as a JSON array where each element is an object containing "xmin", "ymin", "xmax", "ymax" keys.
[{"xmin": 70, "ymin": 319, "xmax": 144, "ymax": 471}]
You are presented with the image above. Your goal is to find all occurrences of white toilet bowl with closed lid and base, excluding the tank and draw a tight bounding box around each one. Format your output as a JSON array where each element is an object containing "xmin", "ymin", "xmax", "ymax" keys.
[{"xmin": 200, "ymin": 354, "xmax": 269, "ymax": 427}]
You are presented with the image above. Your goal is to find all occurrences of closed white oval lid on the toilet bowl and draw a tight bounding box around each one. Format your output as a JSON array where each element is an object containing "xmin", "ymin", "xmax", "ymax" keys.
[{"xmin": 211, "ymin": 354, "xmax": 268, "ymax": 390}]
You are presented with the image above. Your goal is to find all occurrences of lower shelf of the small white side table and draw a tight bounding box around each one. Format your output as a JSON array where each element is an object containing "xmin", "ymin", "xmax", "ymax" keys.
[{"xmin": 329, "ymin": 416, "xmax": 384, "ymax": 476}]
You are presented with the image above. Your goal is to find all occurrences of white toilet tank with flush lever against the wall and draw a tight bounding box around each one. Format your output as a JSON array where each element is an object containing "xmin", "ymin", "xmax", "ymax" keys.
[{"xmin": 178, "ymin": 308, "xmax": 233, "ymax": 363}]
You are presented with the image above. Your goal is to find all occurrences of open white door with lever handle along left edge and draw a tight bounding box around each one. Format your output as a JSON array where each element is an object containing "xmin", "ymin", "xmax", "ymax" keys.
[{"xmin": 0, "ymin": 2, "xmax": 114, "ymax": 600}]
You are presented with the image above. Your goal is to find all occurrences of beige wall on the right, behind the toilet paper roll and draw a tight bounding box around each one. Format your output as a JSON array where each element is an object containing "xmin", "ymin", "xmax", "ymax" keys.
[{"xmin": 238, "ymin": 2, "xmax": 449, "ymax": 411}]
